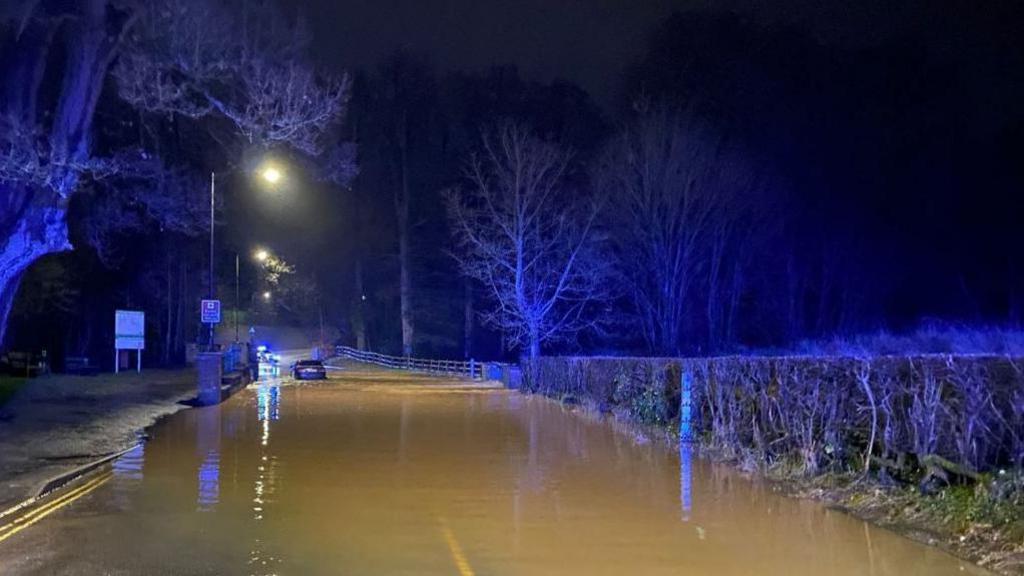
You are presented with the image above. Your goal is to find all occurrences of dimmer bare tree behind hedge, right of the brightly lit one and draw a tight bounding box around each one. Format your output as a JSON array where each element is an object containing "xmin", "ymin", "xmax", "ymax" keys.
[{"xmin": 595, "ymin": 107, "xmax": 757, "ymax": 354}]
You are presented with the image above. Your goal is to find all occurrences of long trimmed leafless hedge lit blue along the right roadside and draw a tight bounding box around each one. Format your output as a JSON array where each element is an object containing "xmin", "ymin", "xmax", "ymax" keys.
[{"xmin": 524, "ymin": 356, "xmax": 1024, "ymax": 477}]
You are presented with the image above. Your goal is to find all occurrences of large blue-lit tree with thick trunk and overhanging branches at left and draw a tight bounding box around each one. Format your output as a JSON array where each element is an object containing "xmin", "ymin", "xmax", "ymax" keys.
[{"xmin": 0, "ymin": 0, "xmax": 348, "ymax": 341}]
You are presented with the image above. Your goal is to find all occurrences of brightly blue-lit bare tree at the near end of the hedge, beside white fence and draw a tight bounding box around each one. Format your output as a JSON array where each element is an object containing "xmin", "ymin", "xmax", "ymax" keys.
[{"xmin": 446, "ymin": 123, "xmax": 607, "ymax": 361}]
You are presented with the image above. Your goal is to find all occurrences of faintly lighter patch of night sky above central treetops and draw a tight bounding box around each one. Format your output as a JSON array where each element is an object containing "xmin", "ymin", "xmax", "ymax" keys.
[{"xmin": 304, "ymin": 0, "xmax": 689, "ymax": 104}]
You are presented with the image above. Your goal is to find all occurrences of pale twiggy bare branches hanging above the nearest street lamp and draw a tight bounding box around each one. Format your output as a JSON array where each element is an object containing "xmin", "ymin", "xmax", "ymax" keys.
[{"xmin": 114, "ymin": 0, "xmax": 349, "ymax": 156}]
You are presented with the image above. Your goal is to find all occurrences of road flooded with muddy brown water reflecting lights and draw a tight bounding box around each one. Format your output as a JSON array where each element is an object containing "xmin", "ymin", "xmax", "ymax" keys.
[{"xmin": 0, "ymin": 364, "xmax": 984, "ymax": 576}]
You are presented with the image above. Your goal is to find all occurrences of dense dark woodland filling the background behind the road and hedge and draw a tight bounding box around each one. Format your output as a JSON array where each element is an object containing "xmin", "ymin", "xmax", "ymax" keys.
[{"xmin": 0, "ymin": 0, "xmax": 1024, "ymax": 365}]
